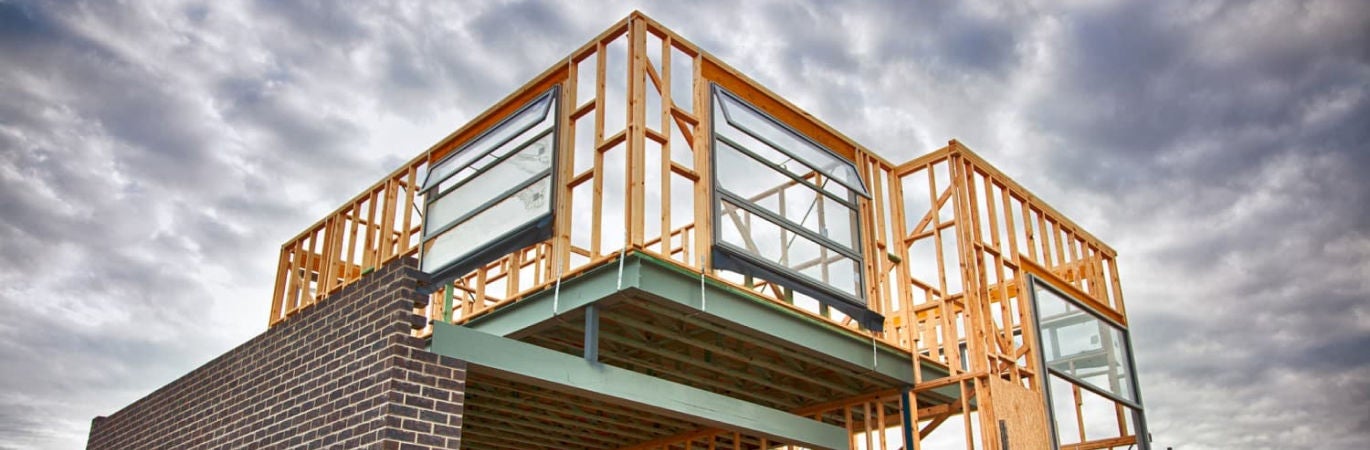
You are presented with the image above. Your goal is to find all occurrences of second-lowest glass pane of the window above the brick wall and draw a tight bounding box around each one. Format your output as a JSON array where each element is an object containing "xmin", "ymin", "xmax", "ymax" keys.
[{"xmin": 423, "ymin": 134, "xmax": 553, "ymax": 233}]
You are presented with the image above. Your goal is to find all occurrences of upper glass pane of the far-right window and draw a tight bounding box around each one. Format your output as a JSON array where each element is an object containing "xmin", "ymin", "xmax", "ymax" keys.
[{"xmin": 1034, "ymin": 285, "xmax": 1136, "ymax": 401}]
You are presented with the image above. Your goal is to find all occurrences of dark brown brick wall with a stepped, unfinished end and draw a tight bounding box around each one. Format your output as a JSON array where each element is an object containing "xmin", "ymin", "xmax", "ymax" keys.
[{"xmin": 88, "ymin": 258, "xmax": 466, "ymax": 449}]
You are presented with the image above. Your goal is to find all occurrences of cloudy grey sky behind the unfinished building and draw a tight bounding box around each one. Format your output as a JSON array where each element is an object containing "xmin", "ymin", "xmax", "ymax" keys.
[{"xmin": 0, "ymin": 0, "xmax": 1370, "ymax": 449}]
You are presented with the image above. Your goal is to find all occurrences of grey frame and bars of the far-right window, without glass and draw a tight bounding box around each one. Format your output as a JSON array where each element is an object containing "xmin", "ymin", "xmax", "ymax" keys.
[{"xmin": 1028, "ymin": 273, "xmax": 1151, "ymax": 450}]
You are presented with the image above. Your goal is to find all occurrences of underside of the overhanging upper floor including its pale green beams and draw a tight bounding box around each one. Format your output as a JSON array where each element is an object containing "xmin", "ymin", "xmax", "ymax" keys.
[{"xmin": 432, "ymin": 254, "xmax": 959, "ymax": 449}]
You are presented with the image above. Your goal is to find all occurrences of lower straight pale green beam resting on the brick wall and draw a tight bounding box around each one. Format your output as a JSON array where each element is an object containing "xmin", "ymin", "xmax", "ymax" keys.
[{"xmin": 433, "ymin": 324, "xmax": 849, "ymax": 449}]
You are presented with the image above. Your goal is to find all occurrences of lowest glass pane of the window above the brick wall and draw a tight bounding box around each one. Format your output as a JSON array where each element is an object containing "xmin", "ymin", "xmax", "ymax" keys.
[{"xmin": 422, "ymin": 177, "xmax": 552, "ymax": 273}]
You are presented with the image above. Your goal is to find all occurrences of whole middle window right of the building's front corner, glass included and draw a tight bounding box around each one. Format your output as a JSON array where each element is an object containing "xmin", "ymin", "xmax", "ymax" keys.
[{"xmin": 712, "ymin": 86, "xmax": 884, "ymax": 329}]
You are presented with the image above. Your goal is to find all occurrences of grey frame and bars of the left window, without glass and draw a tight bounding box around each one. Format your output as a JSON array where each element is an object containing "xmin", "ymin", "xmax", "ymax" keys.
[{"xmin": 418, "ymin": 85, "xmax": 564, "ymax": 295}]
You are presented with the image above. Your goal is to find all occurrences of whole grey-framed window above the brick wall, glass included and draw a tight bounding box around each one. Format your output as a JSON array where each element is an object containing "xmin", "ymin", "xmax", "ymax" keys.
[{"xmin": 419, "ymin": 88, "xmax": 558, "ymax": 284}]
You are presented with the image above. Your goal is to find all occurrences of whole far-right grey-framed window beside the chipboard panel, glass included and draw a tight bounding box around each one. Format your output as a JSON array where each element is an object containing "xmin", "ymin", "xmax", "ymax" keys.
[{"xmin": 1032, "ymin": 279, "xmax": 1149, "ymax": 449}]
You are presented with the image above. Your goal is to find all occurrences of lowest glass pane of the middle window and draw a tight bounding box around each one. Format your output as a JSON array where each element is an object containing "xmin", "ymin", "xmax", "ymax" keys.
[{"xmin": 718, "ymin": 202, "xmax": 863, "ymax": 298}]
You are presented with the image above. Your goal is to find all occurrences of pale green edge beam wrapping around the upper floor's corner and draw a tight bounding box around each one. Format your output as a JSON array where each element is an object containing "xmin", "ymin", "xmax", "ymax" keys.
[{"xmin": 466, "ymin": 252, "xmax": 941, "ymax": 384}]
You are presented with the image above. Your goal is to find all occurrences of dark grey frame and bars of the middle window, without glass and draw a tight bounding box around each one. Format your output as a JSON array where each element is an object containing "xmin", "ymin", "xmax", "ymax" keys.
[{"xmin": 708, "ymin": 82, "xmax": 884, "ymax": 332}]
